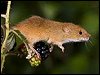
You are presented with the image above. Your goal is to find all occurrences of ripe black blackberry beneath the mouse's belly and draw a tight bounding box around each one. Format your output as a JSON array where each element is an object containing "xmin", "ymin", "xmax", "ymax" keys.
[{"xmin": 34, "ymin": 41, "xmax": 50, "ymax": 60}]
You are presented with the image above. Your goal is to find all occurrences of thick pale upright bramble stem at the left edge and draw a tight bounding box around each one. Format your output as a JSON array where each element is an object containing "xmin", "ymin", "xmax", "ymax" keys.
[{"xmin": 1, "ymin": 1, "xmax": 11, "ymax": 72}]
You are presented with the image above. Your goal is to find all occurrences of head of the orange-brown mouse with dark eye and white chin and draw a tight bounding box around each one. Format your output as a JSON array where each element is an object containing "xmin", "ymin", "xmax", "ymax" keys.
[{"xmin": 63, "ymin": 23, "xmax": 90, "ymax": 42}]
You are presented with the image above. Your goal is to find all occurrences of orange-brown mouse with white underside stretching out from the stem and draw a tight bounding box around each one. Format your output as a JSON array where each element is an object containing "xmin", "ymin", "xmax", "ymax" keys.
[{"xmin": 12, "ymin": 15, "xmax": 91, "ymax": 59}]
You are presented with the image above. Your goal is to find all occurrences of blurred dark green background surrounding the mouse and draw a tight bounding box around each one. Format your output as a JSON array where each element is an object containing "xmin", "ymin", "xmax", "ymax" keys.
[{"xmin": 3, "ymin": 1, "xmax": 99, "ymax": 74}]
